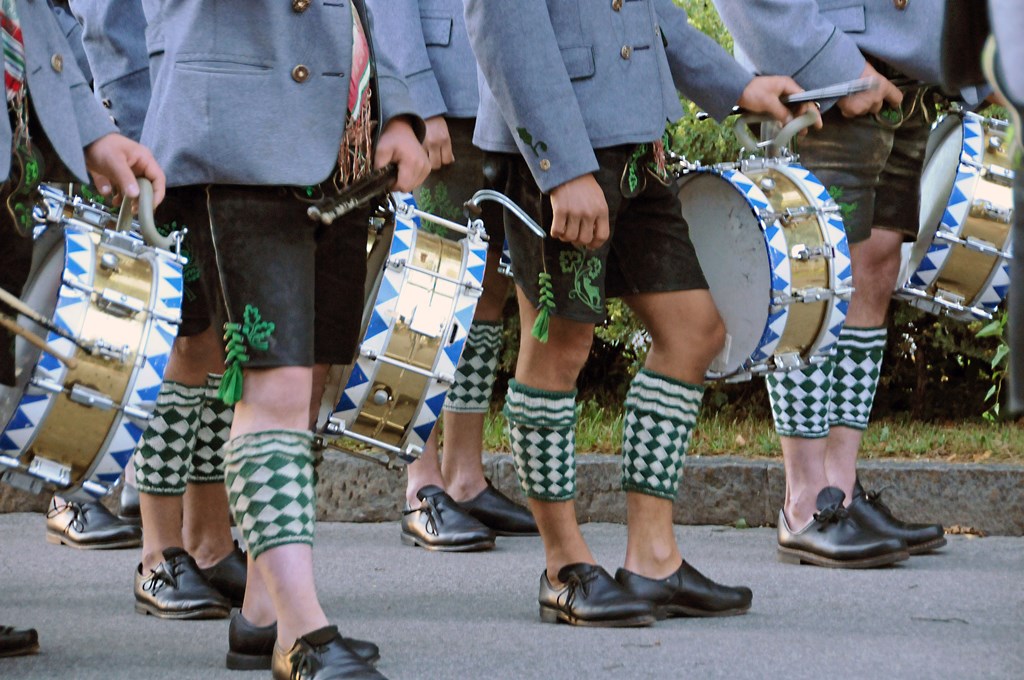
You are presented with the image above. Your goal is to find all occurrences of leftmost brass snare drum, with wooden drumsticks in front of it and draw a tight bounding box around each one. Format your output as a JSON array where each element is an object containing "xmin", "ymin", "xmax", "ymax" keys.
[{"xmin": 0, "ymin": 185, "xmax": 182, "ymax": 500}]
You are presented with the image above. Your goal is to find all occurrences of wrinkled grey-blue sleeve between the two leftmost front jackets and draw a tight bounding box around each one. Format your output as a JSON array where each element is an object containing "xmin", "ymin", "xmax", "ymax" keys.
[{"xmin": 71, "ymin": 0, "xmax": 150, "ymax": 141}]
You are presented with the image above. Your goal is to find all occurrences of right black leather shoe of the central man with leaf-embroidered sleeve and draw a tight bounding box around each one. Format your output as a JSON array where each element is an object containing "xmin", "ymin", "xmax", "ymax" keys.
[{"xmin": 615, "ymin": 559, "xmax": 754, "ymax": 619}]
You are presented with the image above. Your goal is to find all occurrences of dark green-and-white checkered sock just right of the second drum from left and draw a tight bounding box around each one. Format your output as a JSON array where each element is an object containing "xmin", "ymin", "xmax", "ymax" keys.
[{"xmin": 444, "ymin": 322, "xmax": 502, "ymax": 413}]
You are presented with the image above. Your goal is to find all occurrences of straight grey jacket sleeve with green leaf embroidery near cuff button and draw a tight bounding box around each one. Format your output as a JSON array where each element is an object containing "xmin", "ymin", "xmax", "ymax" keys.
[{"xmin": 466, "ymin": 0, "xmax": 598, "ymax": 192}]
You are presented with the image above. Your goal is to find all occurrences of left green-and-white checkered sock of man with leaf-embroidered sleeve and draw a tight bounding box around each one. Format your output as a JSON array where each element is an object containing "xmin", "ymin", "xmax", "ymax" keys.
[{"xmin": 505, "ymin": 380, "xmax": 577, "ymax": 501}]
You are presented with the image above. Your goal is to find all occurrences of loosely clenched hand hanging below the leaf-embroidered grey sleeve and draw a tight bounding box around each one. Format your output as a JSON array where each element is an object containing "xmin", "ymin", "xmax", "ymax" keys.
[{"xmin": 551, "ymin": 175, "xmax": 609, "ymax": 249}]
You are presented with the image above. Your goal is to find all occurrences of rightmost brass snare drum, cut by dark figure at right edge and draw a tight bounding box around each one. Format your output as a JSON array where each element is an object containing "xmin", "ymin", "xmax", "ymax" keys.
[{"xmin": 895, "ymin": 113, "xmax": 1014, "ymax": 322}]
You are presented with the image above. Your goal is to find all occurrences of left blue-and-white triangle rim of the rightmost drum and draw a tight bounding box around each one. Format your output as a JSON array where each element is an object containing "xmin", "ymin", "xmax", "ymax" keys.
[{"xmin": 907, "ymin": 113, "xmax": 985, "ymax": 289}]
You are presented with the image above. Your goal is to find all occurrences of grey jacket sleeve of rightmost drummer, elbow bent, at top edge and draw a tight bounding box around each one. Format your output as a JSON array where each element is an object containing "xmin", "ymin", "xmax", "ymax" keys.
[{"xmin": 715, "ymin": 0, "xmax": 865, "ymax": 89}]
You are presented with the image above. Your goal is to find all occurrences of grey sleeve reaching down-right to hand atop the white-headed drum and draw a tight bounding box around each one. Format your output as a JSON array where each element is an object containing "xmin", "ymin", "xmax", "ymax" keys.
[{"xmin": 655, "ymin": 0, "xmax": 753, "ymax": 120}]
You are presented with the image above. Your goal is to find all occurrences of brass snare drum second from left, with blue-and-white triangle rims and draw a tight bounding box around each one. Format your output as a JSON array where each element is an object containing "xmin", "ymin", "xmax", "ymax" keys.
[{"xmin": 318, "ymin": 194, "xmax": 487, "ymax": 467}]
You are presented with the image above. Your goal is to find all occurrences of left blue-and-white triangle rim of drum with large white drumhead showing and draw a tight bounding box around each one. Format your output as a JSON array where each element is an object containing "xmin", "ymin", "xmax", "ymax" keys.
[{"xmin": 722, "ymin": 170, "xmax": 793, "ymax": 367}]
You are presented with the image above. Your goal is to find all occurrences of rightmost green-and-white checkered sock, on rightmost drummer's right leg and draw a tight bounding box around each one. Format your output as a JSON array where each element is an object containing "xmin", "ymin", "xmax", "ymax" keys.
[{"xmin": 828, "ymin": 327, "xmax": 888, "ymax": 430}]
